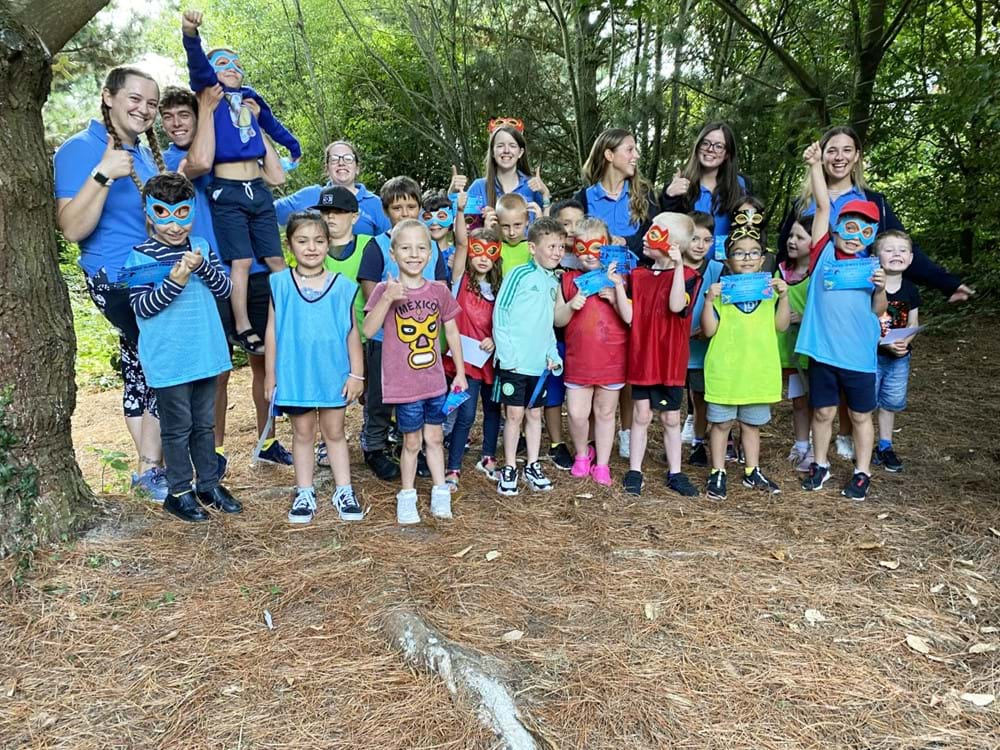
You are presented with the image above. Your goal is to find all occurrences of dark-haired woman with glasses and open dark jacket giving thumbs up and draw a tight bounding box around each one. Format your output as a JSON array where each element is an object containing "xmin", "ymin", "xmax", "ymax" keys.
[{"xmin": 660, "ymin": 122, "xmax": 748, "ymax": 247}]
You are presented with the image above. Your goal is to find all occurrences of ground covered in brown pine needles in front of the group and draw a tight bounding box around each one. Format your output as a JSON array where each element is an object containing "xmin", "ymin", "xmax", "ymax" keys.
[{"xmin": 0, "ymin": 329, "xmax": 1000, "ymax": 750}]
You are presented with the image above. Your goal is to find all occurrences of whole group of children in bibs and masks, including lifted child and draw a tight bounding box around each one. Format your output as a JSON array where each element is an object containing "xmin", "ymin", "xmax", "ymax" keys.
[{"xmin": 109, "ymin": 12, "xmax": 919, "ymax": 524}]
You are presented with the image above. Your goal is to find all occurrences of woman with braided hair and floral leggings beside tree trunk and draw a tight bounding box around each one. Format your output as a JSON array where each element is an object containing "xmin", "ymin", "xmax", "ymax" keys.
[{"xmin": 54, "ymin": 67, "xmax": 167, "ymax": 502}]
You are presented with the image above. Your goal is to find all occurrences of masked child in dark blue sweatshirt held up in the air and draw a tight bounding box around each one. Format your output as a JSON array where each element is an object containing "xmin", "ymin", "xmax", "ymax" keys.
[{"xmin": 181, "ymin": 10, "xmax": 302, "ymax": 354}]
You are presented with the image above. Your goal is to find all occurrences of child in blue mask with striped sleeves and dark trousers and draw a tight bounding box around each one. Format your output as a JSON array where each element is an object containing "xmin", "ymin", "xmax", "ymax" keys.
[{"xmin": 124, "ymin": 172, "xmax": 242, "ymax": 522}]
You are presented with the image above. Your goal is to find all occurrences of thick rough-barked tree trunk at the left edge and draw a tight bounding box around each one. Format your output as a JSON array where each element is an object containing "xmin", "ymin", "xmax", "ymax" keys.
[{"xmin": 0, "ymin": 6, "xmax": 96, "ymax": 556}]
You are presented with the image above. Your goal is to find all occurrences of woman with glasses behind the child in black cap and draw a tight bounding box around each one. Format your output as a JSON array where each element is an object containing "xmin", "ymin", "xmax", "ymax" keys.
[{"xmin": 274, "ymin": 141, "xmax": 392, "ymax": 237}]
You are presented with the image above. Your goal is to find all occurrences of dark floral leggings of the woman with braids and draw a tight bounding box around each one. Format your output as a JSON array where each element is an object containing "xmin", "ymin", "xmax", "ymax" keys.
[{"xmin": 87, "ymin": 269, "xmax": 158, "ymax": 417}]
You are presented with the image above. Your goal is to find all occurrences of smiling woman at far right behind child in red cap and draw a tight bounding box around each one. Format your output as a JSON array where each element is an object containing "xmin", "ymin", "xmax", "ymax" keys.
[{"xmin": 778, "ymin": 125, "xmax": 975, "ymax": 302}]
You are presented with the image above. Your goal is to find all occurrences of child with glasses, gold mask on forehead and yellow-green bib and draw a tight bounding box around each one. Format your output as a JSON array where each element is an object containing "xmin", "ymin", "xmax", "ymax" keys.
[{"xmin": 701, "ymin": 214, "xmax": 790, "ymax": 500}]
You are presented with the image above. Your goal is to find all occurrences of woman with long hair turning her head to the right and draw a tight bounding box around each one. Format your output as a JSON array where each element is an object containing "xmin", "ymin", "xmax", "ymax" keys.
[{"xmin": 573, "ymin": 128, "xmax": 657, "ymax": 258}]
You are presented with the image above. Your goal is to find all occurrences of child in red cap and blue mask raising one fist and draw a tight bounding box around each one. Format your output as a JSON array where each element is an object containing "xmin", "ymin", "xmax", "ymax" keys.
[{"xmin": 795, "ymin": 143, "xmax": 888, "ymax": 500}]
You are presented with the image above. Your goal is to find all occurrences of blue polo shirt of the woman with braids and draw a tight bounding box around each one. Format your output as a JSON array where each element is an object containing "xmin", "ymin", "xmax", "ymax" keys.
[{"xmin": 52, "ymin": 120, "xmax": 160, "ymax": 277}]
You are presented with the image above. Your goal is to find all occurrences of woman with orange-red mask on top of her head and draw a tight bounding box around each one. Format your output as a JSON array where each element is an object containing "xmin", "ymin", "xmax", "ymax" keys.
[{"xmin": 466, "ymin": 123, "xmax": 551, "ymax": 209}]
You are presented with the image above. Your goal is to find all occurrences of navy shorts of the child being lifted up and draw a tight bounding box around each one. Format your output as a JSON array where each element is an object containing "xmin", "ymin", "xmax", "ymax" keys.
[{"xmin": 208, "ymin": 177, "xmax": 282, "ymax": 262}]
